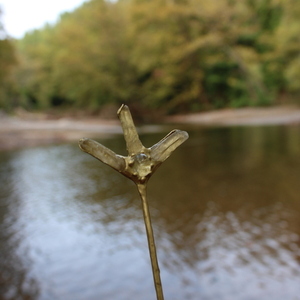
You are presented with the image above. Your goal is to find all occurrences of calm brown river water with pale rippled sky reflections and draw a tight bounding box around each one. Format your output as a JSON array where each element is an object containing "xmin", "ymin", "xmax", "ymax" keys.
[{"xmin": 0, "ymin": 127, "xmax": 300, "ymax": 300}]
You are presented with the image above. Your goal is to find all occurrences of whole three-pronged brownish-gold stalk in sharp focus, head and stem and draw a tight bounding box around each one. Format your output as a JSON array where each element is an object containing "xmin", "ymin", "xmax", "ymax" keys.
[{"xmin": 79, "ymin": 105, "xmax": 188, "ymax": 300}]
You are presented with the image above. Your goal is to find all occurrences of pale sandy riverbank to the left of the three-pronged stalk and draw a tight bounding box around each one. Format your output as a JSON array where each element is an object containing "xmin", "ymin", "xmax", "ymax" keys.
[{"xmin": 0, "ymin": 116, "xmax": 122, "ymax": 150}]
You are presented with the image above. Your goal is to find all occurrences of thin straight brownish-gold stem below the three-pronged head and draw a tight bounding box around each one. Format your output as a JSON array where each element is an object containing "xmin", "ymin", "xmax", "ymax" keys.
[{"xmin": 137, "ymin": 184, "xmax": 164, "ymax": 300}]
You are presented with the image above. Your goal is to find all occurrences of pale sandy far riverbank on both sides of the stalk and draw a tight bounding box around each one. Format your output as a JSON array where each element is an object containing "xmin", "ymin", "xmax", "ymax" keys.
[{"xmin": 0, "ymin": 106, "xmax": 300, "ymax": 150}]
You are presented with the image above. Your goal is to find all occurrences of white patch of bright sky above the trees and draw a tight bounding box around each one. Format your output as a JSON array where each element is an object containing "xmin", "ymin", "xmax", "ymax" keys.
[{"xmin": 0, "ymin": 0, "xmax": 85, "ymax": 39}]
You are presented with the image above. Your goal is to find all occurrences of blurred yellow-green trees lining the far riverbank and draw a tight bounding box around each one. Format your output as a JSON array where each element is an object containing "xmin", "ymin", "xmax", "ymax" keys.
[{"xmin": 4, "ymin": 0, "xmax": 300, "ymax": 113}]
